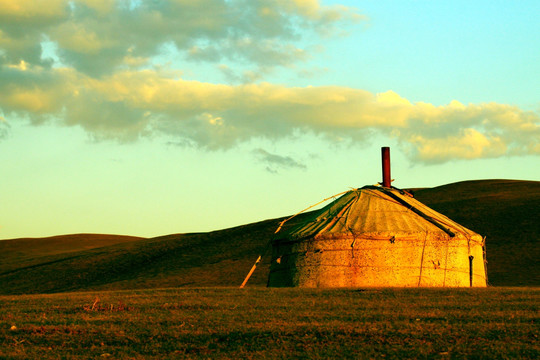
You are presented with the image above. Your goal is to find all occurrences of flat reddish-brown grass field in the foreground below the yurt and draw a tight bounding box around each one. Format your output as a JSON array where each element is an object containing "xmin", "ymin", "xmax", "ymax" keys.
[{"xmin": 0, "ymin": 287, "xmax": 540, "ymax": 359}]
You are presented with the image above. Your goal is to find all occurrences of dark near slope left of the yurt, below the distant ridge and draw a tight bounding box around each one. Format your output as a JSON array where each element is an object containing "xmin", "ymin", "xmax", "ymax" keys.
[{"xmin": 0, "ymin": 220, "xmax": 277, "ymax": 294}]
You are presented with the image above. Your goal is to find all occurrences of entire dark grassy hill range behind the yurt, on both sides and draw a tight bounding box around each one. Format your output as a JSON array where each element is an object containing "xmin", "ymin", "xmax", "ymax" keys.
[{"xmin": 0, "ymin": 180, "xmax": 540, "ymax": 294}]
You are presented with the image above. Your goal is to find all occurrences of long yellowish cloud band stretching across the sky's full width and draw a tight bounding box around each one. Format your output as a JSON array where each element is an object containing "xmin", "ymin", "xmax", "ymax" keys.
[{"xmin": 0, "ymin": 66, "xmax": 540, "ymax": 163}]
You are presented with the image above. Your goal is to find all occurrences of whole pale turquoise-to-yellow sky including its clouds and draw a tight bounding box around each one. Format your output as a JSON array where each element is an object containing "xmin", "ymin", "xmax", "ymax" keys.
[{"xmin": 0, "ymin": 0, "xmax": 540, "ymax": 239}]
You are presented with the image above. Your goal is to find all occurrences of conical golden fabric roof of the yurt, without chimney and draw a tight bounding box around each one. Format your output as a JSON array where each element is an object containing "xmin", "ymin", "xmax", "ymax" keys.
[{"xmin": 276, "ymin": 186, "xmax": 478, "ymax": 240}]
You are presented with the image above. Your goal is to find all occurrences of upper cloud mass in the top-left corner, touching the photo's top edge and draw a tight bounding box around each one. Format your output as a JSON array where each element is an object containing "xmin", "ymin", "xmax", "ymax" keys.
[{"xmin": 0, "ymin": 0, "xmax": 357, "ymax": 76}]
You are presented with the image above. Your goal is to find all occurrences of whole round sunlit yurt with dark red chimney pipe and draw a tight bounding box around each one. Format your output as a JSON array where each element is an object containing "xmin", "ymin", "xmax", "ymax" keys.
[{"xmin": 268, "ymin": 148, "xmax": 487, "ymax": 287}]
